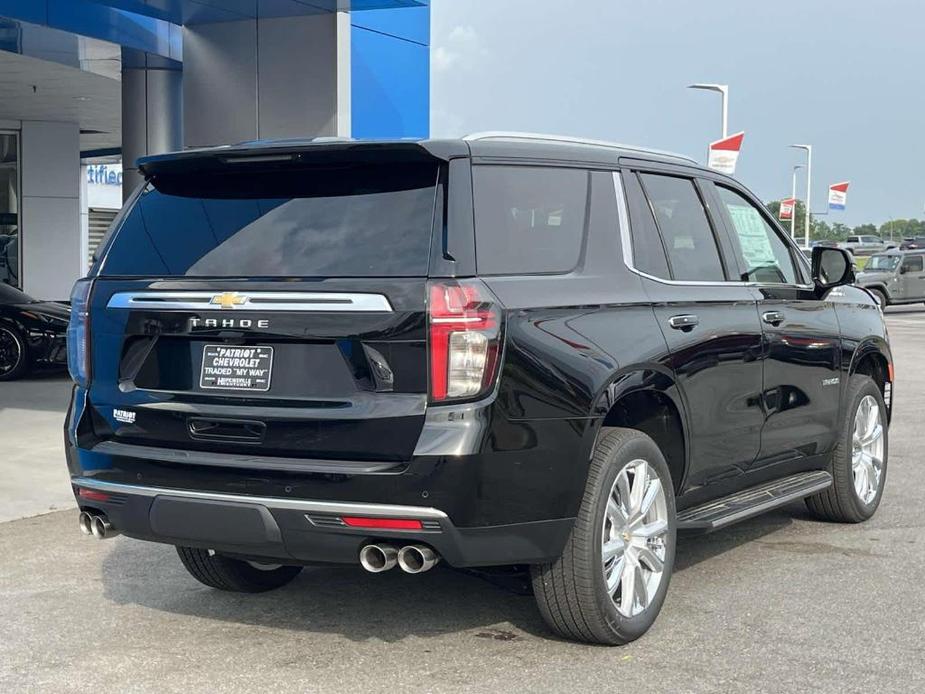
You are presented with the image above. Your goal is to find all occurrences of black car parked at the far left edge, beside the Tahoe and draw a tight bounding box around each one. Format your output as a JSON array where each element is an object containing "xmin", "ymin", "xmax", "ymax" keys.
[{"xmin": 0, "ymin": 282, "xmax": 70, "ymax": 381}]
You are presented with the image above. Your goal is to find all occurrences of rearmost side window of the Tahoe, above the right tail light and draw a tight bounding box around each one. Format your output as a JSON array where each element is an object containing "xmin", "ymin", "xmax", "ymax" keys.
[{"xmin": 472, "ymin": 165, "xmax": 589, "ymax": 275}]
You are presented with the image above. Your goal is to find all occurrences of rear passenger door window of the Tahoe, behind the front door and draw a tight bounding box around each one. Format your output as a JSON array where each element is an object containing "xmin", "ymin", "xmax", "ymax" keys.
[{"xmin": 640, "ymin": 174, "xmax": 726, "ymax": 282}]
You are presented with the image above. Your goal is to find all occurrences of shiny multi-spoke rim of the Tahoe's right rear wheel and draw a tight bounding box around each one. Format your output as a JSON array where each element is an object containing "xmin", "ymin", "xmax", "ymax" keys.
[{"xmin": 601, "ymin": 459, "xmax": 668, "ymax": 617}]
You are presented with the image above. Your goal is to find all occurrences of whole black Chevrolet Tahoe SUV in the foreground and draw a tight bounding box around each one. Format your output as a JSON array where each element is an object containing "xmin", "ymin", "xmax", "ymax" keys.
[{"xmin": 66, "ymin": 133, "xmax": 893, "ymax": 644}]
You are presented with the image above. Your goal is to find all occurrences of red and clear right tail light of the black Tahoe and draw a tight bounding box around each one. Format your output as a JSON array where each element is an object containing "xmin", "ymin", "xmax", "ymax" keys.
[{"xmin": 428, "ymin": 280, "xmax": 501, "ymax": 402}]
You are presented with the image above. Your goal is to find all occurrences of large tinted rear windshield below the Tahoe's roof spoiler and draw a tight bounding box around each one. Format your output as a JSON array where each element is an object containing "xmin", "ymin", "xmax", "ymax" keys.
[{"xmin": 101, "ymin": 164, "xmax": 437, "ymax": 277}]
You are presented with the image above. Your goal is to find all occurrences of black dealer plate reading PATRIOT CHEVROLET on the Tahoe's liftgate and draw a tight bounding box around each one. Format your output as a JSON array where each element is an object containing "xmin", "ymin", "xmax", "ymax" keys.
[{"xmin": 199, "ymin": 344, "xmax": 273, "ymax": 393}]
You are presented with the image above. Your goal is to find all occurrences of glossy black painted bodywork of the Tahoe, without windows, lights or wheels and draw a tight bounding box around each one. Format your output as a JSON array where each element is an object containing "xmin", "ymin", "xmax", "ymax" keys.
[{"xmin": 66, "ymin": 140, "xmax": 892, "ymax": 566}]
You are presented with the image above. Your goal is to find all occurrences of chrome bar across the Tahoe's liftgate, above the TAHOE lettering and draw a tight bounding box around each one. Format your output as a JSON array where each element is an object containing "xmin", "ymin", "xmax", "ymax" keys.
[{"xmin": 106, "ymin": 291, "xmax": 392, "ymax": 313}]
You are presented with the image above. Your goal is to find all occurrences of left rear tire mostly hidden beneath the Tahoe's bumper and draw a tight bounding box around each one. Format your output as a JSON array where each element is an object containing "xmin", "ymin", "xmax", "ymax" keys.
[{"xmin": 177, "ymin": 547, "xmax": 302, "ymax": 593}]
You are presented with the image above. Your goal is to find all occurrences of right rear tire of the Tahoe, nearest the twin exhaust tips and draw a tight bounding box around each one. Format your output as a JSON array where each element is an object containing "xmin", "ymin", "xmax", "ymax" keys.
[{"xmin": 531, "ymin": 428, "xmax": 677, "ymax": 646}]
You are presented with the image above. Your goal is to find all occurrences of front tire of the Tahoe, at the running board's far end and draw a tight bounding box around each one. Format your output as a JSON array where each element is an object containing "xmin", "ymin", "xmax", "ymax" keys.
[{"xmin": 806, "ymin": 374, "xmax": 889, "ymax": 523}]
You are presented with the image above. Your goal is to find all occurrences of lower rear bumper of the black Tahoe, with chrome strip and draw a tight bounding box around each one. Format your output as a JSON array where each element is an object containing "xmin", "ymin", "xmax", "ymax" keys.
[{"xmin": 71, "ymin": 477, "xmax": 573, "ymax": 567}]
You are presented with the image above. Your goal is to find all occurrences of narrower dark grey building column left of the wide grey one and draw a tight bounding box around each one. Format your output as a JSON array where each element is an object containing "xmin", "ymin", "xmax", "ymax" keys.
[{"xmin": 122, "ymin": 48, "xmax": 182, "ymax": 200}]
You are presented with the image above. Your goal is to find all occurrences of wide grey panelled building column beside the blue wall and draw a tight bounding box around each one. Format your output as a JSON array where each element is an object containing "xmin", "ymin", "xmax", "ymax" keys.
[{"xmin": 183, "ymin": 12, "xmax": 350, "ymax": 147}]
